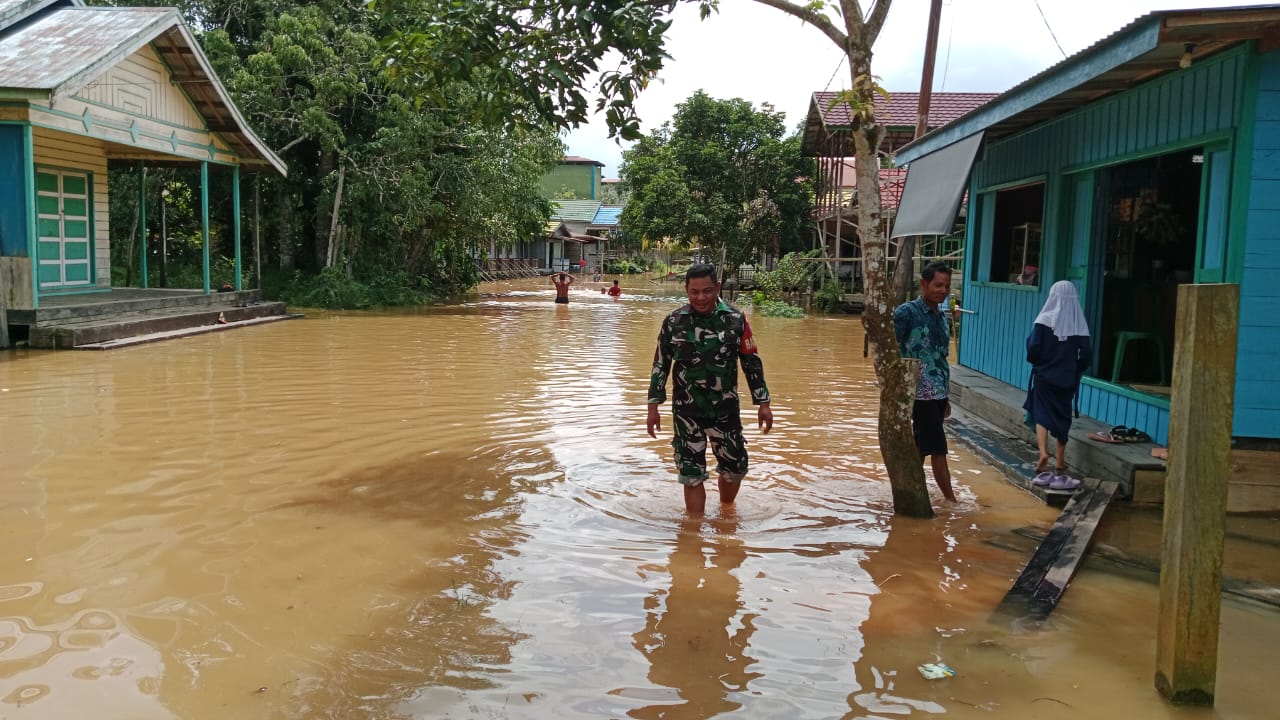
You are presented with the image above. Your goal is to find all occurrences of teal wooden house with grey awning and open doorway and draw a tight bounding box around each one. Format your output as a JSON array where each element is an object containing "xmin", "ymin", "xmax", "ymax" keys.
[{"xmin": 893, "ymin": 5, "xmax": 1280, "ymax": 448}]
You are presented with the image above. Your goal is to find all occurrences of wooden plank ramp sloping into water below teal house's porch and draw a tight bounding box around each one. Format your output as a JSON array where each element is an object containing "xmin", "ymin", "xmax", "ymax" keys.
[{"xmin": 998, "ymin": 478, "xmax": 1119, "ymax": 619}]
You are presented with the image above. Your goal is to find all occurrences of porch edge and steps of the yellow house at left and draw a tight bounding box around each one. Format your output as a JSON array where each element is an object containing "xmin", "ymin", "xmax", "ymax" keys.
[{"xmin": 16, "ymin": 290, "xmax": 301, "ymax": 350}]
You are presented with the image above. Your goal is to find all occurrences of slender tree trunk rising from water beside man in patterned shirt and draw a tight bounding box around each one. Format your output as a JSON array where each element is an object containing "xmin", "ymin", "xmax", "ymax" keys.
[{"xmin": 849, "ymin": 57, "xmax": 933, "ymax": 518}]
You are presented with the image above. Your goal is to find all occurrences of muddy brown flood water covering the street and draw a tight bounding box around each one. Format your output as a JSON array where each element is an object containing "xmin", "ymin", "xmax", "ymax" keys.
[{"xmin": 0, "ymin": 279, "xmax": 1280, "ymax": 720}]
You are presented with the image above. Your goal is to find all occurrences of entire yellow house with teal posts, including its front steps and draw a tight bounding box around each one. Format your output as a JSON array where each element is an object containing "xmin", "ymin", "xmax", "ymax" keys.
[{"xmin": 0, "ymin": 0, "xmax": 287, "ymax": 347}]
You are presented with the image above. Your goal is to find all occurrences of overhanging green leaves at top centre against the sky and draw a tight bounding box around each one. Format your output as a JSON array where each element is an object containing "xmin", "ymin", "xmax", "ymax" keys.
[{"xmin": 376, "ymin": 0, "xmax": 717, "ymax": 140}]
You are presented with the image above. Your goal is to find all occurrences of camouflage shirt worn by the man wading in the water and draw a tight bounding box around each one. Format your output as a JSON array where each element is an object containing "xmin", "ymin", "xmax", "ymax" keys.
[{"xmin": 649, "ymin": 300, "xmax": 769, "ymax": 418}]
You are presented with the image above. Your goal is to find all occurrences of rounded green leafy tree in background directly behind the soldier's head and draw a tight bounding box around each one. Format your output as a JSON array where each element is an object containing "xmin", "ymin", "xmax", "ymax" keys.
[{"xmin": 622, "ymin": 92, "xmax": 813, "ymax": 268}]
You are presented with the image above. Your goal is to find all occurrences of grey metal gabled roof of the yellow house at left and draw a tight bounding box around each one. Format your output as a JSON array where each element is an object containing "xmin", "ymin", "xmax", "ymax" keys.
[{"xmin": 0, "ymin": 0, "xmax": 287, "ymax": 174}]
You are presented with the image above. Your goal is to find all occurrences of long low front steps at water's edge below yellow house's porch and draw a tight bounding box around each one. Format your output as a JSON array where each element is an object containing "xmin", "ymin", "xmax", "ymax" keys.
[{"xmin": 29, "ymin": 302, "xmax": 287, "ymax": 350}]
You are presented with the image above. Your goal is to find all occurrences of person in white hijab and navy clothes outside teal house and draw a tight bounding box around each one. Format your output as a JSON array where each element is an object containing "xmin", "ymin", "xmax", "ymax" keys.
[{"xmin": 1023, "ymin": 281, "xmax": 1093, "ymax": 489}]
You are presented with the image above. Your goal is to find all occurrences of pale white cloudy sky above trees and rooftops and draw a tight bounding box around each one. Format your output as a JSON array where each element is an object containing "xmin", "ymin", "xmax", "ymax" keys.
[{"xmin": 564, "ymin": 0, "xmax": 1280, "ymax": 177}]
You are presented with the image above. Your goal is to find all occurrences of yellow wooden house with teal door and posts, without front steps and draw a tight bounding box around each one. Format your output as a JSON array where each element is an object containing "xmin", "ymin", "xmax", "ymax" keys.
[{"xmin": 0, "ymin": 0, "xmax": 285, "ymax": 316}]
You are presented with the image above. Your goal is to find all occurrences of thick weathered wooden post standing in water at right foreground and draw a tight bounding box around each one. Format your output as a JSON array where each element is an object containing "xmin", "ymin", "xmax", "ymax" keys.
[{"xmin": 1156, "ymin": 284, "xmax": 1240, "ymax": 705}]
